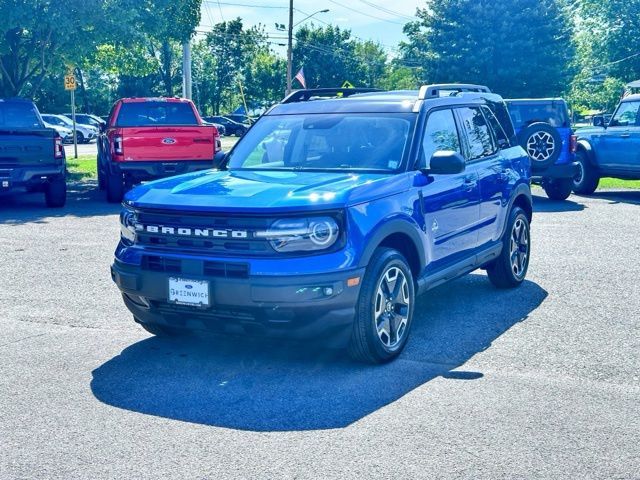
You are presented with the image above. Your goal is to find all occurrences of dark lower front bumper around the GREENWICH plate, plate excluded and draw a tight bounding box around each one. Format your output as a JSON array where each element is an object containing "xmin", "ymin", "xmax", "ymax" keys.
[{"xmin": 111, "ymin": 260, "xmax": 364, "ymax": 347}]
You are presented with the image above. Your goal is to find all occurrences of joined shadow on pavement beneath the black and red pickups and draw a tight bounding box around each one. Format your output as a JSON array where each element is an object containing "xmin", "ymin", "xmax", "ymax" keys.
[{"xmin": 0, "ymin": 181, "xmax": 120, "ymax": 225}]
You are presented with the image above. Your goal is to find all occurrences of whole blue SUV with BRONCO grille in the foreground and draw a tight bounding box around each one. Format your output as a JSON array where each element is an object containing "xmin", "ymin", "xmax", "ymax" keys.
[{"xmin": 111, "ymin": 85, "xmax": 532, "ymax": 363}]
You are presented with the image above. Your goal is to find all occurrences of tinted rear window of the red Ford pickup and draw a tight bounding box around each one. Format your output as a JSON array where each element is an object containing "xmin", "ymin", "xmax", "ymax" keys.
[{"xmin": 116, "ymin": 102, "xmax": 198, "ymax": 127}]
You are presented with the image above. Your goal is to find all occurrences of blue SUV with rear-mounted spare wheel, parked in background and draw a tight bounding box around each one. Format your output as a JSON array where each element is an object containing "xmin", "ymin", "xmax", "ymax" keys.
[{"xmin": 506, "ymin": 98, "xmax": 578, "ymax": 200}]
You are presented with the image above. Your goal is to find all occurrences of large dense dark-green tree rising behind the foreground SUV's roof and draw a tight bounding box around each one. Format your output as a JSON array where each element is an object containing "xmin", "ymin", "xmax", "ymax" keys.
[{"xmin": 401, "ymin": 0, "xmax": 574, "ymax": 97}]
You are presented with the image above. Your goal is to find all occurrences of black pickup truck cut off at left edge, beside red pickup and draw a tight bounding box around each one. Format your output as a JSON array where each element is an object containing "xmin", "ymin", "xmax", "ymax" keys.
[{"xmin": 0, "ymin": 98, "xmax": 67, "ymax": 207}]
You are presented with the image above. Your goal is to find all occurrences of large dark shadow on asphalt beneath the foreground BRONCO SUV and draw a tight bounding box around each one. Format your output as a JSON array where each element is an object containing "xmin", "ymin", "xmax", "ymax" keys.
[{"xmin": 91, "ymin": 275, "xmax": 547, "ymax": 431}]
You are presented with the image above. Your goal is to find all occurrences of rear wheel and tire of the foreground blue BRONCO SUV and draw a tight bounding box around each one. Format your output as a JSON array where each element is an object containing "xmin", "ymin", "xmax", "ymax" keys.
[{"xmin": 487, "ymin": 207, "xmax": 531, "ymax": 288}]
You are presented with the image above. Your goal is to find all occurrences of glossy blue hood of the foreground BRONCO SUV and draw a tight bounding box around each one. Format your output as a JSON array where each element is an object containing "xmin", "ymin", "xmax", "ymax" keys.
[{"xmin": 125, "ymin": 170, "xmax": 410, "ymax": 212}]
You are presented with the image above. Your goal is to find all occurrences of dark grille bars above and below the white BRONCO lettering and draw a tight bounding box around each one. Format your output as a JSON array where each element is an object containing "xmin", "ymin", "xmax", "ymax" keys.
[{"xmin": 137, "ymin": 210, "xmax": 275, "ymax": 256}]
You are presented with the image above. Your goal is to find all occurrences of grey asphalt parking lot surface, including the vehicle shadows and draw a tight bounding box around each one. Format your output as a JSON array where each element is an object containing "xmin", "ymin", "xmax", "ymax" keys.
[{"xmin": 0, "ymin": 184, "xmax": 640, "ymax": 479}]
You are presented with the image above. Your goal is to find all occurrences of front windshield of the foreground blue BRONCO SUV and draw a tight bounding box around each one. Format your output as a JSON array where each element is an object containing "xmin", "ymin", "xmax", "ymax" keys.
[{"xmin": 229, "ymin": 113, "xmax": 414, "ymax": 171}]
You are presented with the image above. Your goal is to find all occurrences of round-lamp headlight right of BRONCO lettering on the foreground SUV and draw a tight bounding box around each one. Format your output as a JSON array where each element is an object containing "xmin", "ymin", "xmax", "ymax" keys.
[{"xmin": 256, "ymin": 217, "xmax": 340, "ymax": 253}]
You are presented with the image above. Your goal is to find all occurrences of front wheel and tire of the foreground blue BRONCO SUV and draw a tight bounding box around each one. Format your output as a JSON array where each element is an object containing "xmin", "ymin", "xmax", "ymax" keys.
[{"xmin": 349, "ymin": 248, "xmax": 415, "ymax": 364}]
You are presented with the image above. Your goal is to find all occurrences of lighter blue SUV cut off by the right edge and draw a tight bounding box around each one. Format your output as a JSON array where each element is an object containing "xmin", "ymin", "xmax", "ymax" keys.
[{"xmin": 573, "ymin": 94, "xmax": 640, "ymax": 195}]
